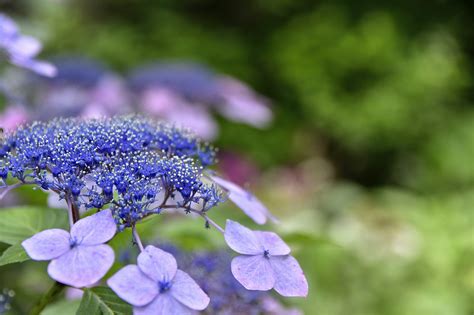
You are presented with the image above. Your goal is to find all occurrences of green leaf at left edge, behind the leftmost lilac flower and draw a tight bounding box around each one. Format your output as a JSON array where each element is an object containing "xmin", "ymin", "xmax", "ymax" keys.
[{"xmin": 0, "ymin": 207, "xmax": 67, "ymax": 245}]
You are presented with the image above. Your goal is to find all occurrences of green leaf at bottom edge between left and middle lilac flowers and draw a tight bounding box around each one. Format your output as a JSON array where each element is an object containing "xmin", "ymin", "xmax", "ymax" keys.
[{"xmin": 76, "ymin": 287, "xmax": 132, "ymax": 315}]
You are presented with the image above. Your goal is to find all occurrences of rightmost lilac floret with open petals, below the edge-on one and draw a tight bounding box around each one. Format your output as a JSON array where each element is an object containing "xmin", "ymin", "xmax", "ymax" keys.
[{"xmin": 224, "ymin": 220, "xmax": 308, "ymax": 296}]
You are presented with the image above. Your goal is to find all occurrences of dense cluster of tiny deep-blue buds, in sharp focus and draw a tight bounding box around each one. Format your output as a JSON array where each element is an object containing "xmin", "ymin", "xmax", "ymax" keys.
[{"xmin": 0, "ymin": 116, "xmax": 222, "ymax": 229}]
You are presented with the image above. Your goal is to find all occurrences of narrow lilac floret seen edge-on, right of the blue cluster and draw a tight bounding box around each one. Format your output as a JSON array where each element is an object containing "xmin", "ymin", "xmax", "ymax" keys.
[{"xmin": 210, "ymin": 176, "xmax": 278, "ymax": 224}]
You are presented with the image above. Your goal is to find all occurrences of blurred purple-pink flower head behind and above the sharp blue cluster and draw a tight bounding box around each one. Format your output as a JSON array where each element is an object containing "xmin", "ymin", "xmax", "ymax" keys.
[{"xmin": 129, "ymin": 62, "xmax": 272, "ymax": 139}]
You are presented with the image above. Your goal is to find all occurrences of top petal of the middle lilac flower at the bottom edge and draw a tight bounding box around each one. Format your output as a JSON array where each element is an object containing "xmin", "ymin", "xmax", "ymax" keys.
[{"xmin": 137, "ymin": 245, "xmax": 178, "ymax": 282}]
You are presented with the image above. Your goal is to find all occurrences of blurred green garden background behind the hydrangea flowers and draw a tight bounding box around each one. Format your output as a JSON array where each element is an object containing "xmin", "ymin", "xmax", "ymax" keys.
[{"xmin": 0, "ymin": 0, "xmax": 474, "ymax": 315}]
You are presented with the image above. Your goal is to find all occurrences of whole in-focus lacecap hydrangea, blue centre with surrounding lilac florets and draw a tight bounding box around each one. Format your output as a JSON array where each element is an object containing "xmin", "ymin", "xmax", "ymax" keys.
[{"xmin": 0, "ymin": 116, "xmax": 308, "ymax": 314}]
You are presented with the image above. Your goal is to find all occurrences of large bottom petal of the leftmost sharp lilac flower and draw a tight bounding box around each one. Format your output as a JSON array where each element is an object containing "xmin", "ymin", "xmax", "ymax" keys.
[{"xmin": 48, "ymin": 244, "xmax": 114, "ymax": 288}]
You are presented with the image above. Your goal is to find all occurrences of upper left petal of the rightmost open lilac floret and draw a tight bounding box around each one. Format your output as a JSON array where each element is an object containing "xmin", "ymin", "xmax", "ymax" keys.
[{"xmin": 224, "ymin": 220, "xmax": 264, "ymax": 255}]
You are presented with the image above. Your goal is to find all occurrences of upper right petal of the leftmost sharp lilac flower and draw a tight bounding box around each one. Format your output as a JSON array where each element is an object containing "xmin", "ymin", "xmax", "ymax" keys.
[{"xmin": 71, "ymin": 209, "xmax": 117, "ymax": 245}]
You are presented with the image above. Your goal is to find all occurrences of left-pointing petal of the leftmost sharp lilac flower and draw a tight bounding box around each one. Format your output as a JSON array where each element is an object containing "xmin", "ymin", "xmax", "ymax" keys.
[{"xmin": 21, "ymin": 229, "xmax": 70, "ymax": 260}]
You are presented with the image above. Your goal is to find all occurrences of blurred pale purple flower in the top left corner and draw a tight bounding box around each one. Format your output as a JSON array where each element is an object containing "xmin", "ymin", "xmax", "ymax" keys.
[{"xmin": 0, "ymin": 13, "xmax": 56, "ymax": 77}]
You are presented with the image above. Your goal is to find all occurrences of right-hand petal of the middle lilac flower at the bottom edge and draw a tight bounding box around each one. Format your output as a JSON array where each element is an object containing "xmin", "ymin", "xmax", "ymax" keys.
[{"xmin": 170, "ymin": 269, "xmax": 209, "ymax": 311}]
